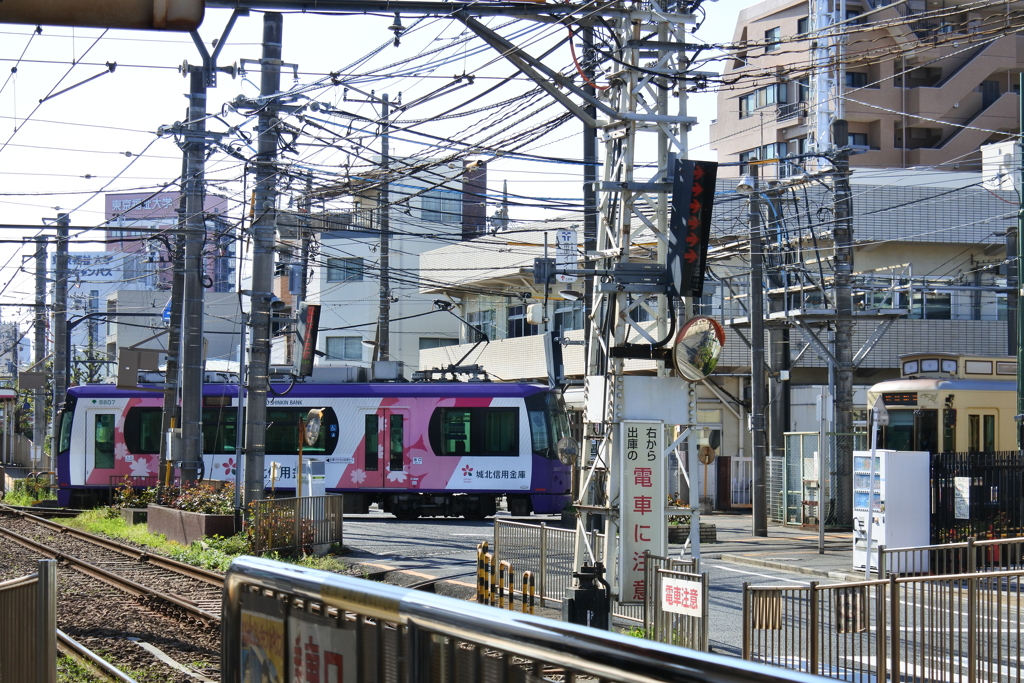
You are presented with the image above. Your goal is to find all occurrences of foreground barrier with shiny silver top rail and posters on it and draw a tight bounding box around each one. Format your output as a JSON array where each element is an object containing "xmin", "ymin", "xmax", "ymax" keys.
[{"xmin": 221, "ymin": 557, "xmax": 818, "ymax": 683}]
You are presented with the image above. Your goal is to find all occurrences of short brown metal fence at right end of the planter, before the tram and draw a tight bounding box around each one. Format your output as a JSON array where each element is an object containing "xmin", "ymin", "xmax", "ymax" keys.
[{"xmin": 249, "ymin": 496, "xmax": 344, "ymax": 554}]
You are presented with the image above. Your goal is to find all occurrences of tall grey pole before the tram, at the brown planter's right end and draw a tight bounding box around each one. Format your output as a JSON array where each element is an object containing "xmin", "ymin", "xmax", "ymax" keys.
[{"xmin": 243, "ymin": 12, "xmax": 284, "ymax": 506}]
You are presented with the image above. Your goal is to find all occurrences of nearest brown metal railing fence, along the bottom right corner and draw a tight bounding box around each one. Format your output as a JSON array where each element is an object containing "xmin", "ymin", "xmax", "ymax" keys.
[{"xmin": 742, "ymin": 571, "xmax": 1024, "ymax": 683}]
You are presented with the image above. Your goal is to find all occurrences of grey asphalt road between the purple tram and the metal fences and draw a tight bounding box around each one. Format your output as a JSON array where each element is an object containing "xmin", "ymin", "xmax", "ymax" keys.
[{"xmin": 344, "ymin": 510, "xmax": 810, "ymax": 656}]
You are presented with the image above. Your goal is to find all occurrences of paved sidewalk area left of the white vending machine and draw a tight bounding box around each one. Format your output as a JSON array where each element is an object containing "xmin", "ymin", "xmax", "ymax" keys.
[{"xmin": 673, "ymin": 513, "xmax": 864, "ymax": 582}]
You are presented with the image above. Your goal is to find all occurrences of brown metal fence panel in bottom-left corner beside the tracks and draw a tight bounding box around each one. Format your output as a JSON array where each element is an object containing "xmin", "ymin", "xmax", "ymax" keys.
[{"xmin": 0, "ymin": 560, "xmax": 57, "ymax": 683}]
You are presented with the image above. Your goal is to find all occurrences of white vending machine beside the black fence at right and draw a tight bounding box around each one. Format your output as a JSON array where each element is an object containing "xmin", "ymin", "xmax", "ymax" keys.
[{"xmin": 853, "ymin": 451, "xmax": 932, "ymax": 573}]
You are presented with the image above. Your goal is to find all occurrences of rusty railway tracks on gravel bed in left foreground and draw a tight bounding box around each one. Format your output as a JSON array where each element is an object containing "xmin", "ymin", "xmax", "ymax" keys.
[{"xmin": 0, "ymin": 506, "xmax": 223, "ymax": 683}]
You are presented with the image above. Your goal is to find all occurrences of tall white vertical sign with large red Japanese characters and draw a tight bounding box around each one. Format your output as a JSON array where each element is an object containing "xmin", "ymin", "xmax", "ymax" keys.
[{"xmin": 618, "ymin": 420, "xmax": 668, "ymax": 603}]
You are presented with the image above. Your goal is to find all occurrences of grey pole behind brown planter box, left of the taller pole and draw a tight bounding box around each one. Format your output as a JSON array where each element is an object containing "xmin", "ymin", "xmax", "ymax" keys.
[{"xmin": 181, "ymin": 67, "xmax": 206, "ymax": 484}]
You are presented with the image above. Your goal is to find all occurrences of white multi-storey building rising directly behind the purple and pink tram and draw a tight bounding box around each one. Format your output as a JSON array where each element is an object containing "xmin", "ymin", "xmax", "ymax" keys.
[{"xmin": 292, "ymin": 159, "xmax": 486, "ymax": 379}]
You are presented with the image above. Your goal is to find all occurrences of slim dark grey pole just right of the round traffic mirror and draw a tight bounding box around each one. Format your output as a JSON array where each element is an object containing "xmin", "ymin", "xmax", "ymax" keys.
[{"xmin": 746, "ymin": 176, "xmax": 768, "ymax": 537}]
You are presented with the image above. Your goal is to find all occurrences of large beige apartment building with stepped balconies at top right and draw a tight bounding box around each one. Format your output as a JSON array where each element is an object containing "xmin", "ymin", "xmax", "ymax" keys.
[{"xmin": 711, "ymin": 0, "xmax": 1024, "ymax": 178}]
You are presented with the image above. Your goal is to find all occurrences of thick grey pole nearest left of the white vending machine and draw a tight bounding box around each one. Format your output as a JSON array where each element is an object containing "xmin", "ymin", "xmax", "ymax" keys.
[{"xmin": 822, "ymin": 119, "xmax": 854, "ymax": 525}]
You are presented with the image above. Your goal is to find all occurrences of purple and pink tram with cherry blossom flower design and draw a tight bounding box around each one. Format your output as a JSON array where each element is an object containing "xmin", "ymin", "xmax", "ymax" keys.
[{"xmin": 56, "ymin": 382, "xmax": 571, "ymax": 518}]
